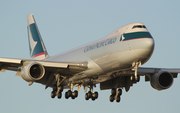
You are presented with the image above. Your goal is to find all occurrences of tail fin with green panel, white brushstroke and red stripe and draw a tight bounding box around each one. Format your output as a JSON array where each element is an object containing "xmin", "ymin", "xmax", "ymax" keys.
[{"xmin": 27, "ymin": 14, "xmax": 49, "ymax": 60}]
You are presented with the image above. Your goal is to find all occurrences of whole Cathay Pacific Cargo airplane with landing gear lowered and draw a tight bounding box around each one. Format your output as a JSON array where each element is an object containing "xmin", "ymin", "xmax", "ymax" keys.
[{"xmin": 0, "ymin": 14, "xmax": 180, "ymax": 102}]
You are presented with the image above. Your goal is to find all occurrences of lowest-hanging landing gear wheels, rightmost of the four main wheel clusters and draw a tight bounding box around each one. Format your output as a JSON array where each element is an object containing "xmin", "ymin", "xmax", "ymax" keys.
[{"xmin": 109, "ymin": 88, "xmax": 122, "ymax": 102}]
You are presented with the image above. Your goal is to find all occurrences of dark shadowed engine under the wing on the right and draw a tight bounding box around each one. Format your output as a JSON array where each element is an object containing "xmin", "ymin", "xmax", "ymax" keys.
[{"xmin": 150, "ymin": 71, "xmax": 174, "ymax": 90}]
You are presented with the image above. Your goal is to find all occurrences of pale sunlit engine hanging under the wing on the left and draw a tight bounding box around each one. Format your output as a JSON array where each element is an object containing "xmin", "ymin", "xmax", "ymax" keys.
[{"xmin": 21, "ymin": 62, "xmax": 45, "ymax": 82}]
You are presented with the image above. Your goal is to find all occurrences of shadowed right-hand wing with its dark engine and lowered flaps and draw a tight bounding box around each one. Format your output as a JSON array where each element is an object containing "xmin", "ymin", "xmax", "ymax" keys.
[{"xmin": 100, "ymin": 67, "xmax": 180, "ymax": 91}]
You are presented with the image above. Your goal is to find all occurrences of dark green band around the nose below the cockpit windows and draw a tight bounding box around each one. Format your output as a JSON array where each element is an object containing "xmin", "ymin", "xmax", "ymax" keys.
[{"xmin": 123, "ymin": 32, "xmax": 152, "ymax": 41}]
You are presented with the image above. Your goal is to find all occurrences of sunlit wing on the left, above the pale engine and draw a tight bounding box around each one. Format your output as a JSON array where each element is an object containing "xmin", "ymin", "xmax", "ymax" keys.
[{"xmin": 0, "ymin": 58, "xmax": 87, "ymax": 75}]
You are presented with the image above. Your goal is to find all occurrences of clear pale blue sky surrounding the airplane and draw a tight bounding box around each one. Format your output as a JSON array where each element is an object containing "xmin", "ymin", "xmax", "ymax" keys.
[{"xmin": 0, "ymin": 0, "xmax": 180, "ymax": 113}]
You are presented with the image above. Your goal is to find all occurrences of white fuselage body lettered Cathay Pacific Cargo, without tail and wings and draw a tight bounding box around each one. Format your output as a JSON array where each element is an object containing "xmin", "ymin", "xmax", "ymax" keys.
[{"xmin": 46, "ymin": 23, "xmax": 154, "ymax": 84}]
